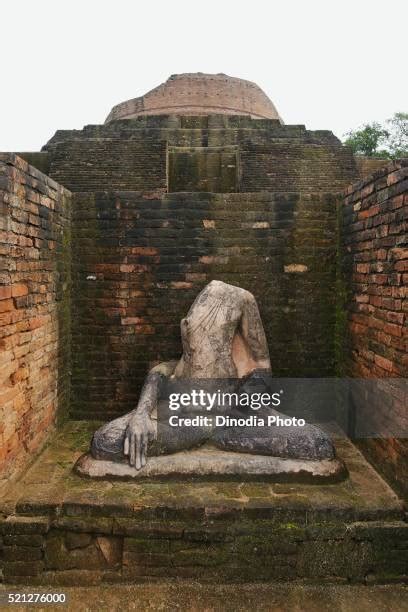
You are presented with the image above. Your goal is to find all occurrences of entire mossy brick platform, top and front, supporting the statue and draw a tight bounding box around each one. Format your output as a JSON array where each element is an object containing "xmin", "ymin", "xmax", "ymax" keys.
[{"xmin": 0, "ymin": 422, "xmax": 408, "ymax": 586}]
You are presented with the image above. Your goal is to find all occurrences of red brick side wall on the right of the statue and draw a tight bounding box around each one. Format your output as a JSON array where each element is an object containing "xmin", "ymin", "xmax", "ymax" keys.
[{"xmin": 343, "ymin": 160, "xmax": 408, "ymax": 492}]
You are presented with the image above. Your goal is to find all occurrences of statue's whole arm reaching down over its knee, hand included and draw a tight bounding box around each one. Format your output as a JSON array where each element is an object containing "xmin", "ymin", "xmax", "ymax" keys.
[{"xmin": 123, "ymin": 361, "xmax": 177, "ymax": 470}]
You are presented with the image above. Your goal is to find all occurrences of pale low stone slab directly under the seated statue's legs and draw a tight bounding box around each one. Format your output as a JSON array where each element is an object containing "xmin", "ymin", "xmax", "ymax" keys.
[{"xmin": 75, "ymin": 446, "xmax": 347, "ymax": 483}]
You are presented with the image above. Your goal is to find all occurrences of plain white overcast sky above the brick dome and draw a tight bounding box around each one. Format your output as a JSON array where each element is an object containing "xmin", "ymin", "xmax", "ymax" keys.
[{"xmin": 0, "ymin": 0, "xmax": 408, "ymax": 151}]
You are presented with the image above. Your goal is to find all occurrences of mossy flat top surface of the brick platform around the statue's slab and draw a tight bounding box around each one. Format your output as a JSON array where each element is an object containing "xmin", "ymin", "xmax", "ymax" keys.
[{"xmin": 0, "ymin": 421, "xmax": 404, "ymax": 533}]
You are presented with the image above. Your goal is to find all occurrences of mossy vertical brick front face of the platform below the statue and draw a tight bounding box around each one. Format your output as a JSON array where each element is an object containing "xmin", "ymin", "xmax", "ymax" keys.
[{"xmin": 0, "ymin": 509, "xmax": 408, "ymax": 586}]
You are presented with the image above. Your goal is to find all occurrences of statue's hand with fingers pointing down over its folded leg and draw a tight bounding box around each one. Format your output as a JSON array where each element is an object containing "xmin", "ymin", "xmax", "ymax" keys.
[{"xmin": 123, "ymin": 413, "xmax": 157, "ymax": 470}]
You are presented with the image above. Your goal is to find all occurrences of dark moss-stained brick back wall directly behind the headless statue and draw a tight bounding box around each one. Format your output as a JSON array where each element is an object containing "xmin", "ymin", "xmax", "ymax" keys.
[{"xmin": 72, "ymin": 192, "xmax": 336, "ymax": 419}]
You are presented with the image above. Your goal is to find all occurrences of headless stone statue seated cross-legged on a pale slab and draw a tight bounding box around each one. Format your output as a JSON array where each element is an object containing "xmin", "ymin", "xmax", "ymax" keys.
[{"xmin": 87, "ymin": 281, "xmax": 335, "ymax": 471}]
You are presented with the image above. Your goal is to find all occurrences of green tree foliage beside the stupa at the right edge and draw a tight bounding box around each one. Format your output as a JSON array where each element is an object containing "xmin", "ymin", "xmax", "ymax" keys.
[{"xmin": 344, "ymin": 113, "xmax": 408, "ymax": 159}]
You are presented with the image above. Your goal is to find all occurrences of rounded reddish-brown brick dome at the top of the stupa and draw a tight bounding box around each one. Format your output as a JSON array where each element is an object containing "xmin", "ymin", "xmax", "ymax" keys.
[{"xmin": 105, "ymin": 72, "xmax": 283, "ymax": 123}]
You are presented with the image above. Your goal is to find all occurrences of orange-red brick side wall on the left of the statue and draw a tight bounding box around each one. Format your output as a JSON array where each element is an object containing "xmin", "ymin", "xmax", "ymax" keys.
[{"xmin": 0, "ymin": 154, "xmax": 70, "ymax": 482}]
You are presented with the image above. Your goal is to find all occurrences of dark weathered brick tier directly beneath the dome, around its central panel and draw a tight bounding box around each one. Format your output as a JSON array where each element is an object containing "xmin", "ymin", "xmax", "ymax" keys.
[{"xmin": 46, "ymin": 116, "xmax": 358, "ymax": 192}]
